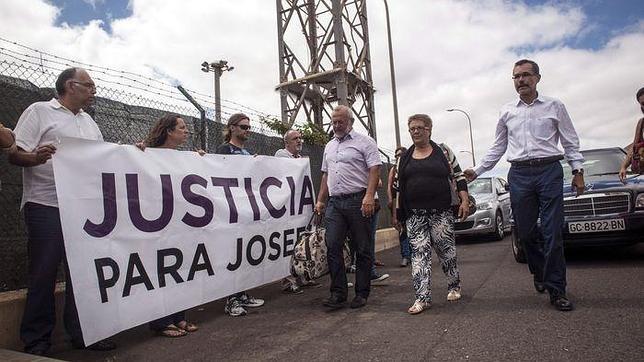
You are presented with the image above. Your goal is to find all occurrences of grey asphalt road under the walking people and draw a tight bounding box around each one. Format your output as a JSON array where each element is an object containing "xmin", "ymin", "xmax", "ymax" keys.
[{"xmin": 52, "ymin": 237, "xmax": 644, "ymax": 361}]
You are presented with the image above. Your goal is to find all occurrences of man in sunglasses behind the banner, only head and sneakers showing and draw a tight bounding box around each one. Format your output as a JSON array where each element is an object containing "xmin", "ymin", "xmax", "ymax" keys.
[{"xmin": 217, "ymin": 113, "xmax": 264, "ymax": 317}]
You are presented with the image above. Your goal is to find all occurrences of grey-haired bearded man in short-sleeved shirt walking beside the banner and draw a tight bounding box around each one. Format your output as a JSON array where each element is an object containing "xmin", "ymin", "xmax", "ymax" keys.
[{"xmin": 315, "ymin": 105, "xmax": 382, "ymax": 310}]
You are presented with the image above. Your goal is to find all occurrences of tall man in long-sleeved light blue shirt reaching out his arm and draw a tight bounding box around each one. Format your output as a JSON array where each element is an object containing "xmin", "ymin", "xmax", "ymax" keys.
[{"xmin": 465, "ymin": 59, "xmax": 584, "ymax": 311}]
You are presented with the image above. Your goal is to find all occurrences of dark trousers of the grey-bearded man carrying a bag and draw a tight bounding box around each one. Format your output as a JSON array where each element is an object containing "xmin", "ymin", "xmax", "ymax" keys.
[{"xmin": 325, "ymin": 193, "xmax": 374, "ymax": 300}]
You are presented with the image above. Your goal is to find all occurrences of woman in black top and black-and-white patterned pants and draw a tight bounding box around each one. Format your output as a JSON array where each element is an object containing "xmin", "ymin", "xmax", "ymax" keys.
[{"xmin": 394, "ymin": 114, "xmax": 468, "ymax": 314}]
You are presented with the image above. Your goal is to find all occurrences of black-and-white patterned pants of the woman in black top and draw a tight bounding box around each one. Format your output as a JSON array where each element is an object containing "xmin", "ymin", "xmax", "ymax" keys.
[{"xmin": 406, "ymin": 209, "xmax": 461, "ymax": 302}]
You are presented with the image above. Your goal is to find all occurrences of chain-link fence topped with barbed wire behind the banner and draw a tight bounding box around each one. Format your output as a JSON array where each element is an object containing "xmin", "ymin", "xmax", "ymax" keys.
[{"xmin": 0, "ymin": 38, "xmax": 390, "ymax": 291}]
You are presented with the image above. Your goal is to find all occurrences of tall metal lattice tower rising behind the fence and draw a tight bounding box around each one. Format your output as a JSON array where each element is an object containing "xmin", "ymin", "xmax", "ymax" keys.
[{"xmin": 276, "ymin": 0, "xmax": 376, "ymax": 139}]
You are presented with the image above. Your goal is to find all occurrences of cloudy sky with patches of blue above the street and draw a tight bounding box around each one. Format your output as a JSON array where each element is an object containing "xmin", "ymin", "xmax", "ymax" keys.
[{"xmin": 0, "ymin": 0, "xmax": 644, "ymax": 174}]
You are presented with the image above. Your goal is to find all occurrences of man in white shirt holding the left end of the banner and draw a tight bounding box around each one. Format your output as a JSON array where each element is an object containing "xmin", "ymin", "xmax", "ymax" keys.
[{"xmin": 9, "ymin": 68, "xmax": 116, "ymax": 355}]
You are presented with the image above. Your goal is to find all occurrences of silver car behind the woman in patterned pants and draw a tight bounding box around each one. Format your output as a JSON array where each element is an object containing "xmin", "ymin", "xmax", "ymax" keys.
[{"xmin": 454, "ymin": 177, "xmax": 512, "ymax": 240}]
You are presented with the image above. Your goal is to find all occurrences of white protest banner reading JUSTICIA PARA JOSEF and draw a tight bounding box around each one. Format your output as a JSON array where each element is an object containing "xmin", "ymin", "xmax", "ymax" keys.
[{"xmin": 53, "ymin": 139, "xmax": 314, "ymax": 345}]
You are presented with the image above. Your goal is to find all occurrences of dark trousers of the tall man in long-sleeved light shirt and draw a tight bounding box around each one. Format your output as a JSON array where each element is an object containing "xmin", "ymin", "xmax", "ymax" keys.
[{"xmin": 508, "ymin": 162, "xmax": 566, "ymax": 296}]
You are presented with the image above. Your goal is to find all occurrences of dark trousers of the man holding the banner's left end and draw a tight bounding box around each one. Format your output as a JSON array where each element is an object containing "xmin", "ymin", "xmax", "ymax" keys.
[{"xmin": 20, "ymin": 202, "xmax": 83, "ymax": 351}]
